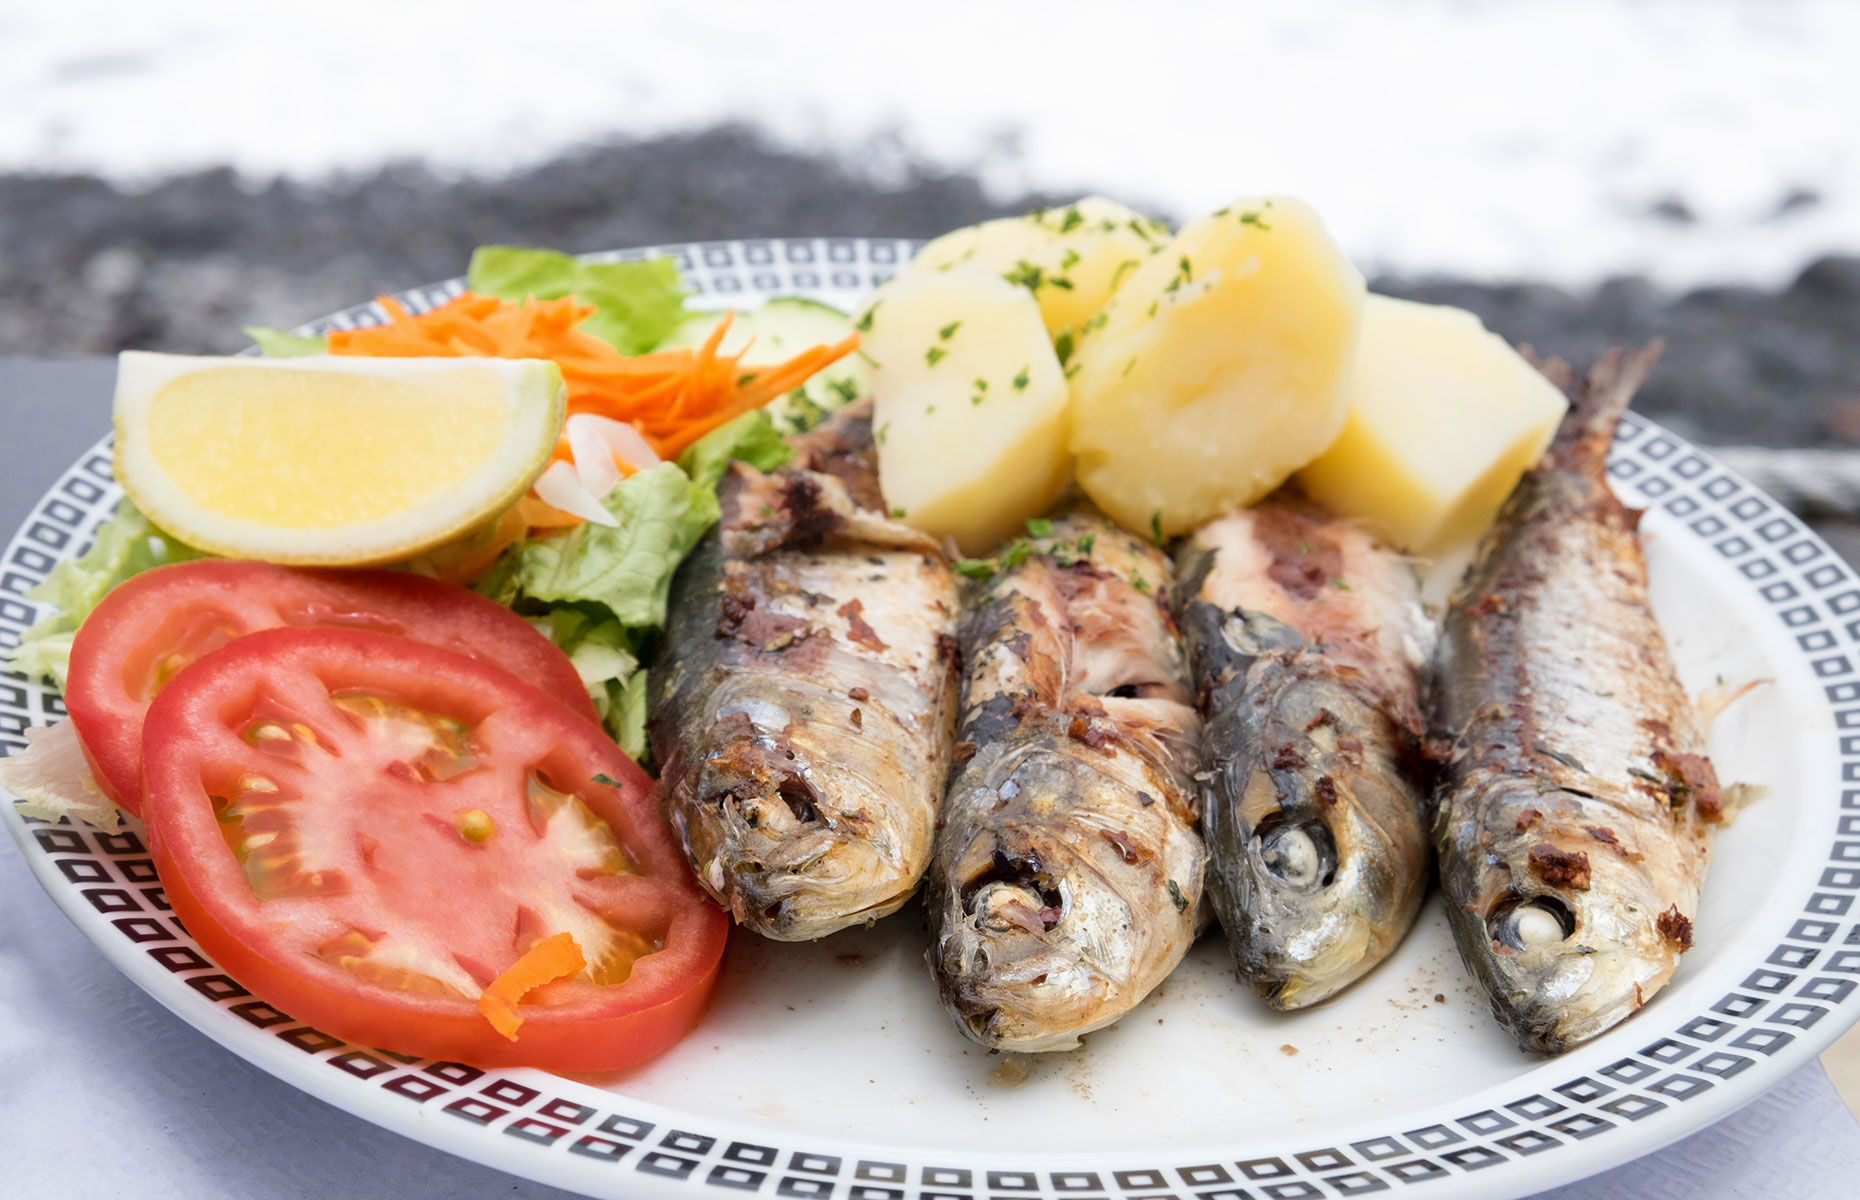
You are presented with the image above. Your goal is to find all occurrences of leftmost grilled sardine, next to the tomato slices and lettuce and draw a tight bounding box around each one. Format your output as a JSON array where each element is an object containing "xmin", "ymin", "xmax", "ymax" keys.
[{"xmin": 647, "ymin": 404, "xmax": 960, "ymax": 941}]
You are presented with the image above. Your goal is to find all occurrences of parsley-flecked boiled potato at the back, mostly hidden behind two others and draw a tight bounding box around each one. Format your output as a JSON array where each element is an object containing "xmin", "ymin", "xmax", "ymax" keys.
[{"xmin": 908, "ymin": 195, "xmax": 1168, "ymax": 336}]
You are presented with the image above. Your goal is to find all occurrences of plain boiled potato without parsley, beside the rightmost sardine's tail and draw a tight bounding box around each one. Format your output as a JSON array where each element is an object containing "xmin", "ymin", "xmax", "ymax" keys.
[{"xmin": 1298, "ymin": 296, "xmax": 1568, "ymax": 551}]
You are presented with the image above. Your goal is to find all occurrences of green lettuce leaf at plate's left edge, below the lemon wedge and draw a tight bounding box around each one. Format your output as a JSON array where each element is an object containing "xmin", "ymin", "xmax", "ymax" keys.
[{"xmin": 6, "ymin": 499, "xmax": 210, "ymax": 688}]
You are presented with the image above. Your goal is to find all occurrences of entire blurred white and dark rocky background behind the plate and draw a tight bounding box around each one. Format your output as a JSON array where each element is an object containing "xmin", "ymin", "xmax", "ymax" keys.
[{"xmin": 0, "ymin": 0, "xmax": 1860, "ymax": 1098}]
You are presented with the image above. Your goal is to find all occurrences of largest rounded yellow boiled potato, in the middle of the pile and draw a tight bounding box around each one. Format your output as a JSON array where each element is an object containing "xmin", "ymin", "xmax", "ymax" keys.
[{"xmin": 1071, "ymin": 197, "xmax": 1363, "ymax": 536}]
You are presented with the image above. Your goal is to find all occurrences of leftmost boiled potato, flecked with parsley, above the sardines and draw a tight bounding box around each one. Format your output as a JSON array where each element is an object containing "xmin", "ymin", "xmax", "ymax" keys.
[{"xmin": 859, "ymin": 266, "xmax": 1071, "ymax": 554}]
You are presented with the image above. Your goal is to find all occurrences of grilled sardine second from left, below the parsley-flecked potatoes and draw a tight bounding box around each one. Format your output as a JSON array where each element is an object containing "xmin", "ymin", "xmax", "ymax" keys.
[{"xmin": 924, "ymin": 515, "xmax": 1205, "ymax": 1051}]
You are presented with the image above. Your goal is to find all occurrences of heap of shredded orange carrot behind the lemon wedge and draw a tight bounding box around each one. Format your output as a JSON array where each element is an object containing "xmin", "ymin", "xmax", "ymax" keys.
[{"xmin": 329, "ymin": 292, "xmax": 859, "ymax": 460}]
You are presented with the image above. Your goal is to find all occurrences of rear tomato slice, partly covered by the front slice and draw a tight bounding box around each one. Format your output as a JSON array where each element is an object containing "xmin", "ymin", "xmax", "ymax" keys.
[{"xmin": 65, "ymin": 560, "xmax": 595, "ymax": 813}]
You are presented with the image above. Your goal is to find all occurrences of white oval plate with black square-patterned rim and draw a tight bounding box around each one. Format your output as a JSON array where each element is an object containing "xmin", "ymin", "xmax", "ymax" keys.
[{"xmin": 0, "ymin": 238, "xmax": 1860, "ymax": 1200}]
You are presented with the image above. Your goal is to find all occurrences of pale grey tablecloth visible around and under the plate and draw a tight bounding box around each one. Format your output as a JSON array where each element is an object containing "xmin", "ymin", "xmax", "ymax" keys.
[{"xmin": 0, "ymin": 359, "xmax": 1860, "ymax": 1200}]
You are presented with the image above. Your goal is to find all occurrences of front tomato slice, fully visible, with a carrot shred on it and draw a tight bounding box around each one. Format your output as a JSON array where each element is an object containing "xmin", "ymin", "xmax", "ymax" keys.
[{"xmin": 143, "ymin": 629, "xmax": 729, "ymax": 1072}]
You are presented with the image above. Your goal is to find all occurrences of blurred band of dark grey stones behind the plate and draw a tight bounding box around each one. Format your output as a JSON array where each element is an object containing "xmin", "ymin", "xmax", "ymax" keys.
[{"xmin": 0, "ymin": 128, "xmax": 1860, "ymax": 447}]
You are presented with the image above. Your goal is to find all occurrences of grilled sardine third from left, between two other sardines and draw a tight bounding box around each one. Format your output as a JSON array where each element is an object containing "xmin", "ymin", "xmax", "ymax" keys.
[{"xmin": 1177, "ymin": 493, "xmax": 1434, "ymax": 1010}]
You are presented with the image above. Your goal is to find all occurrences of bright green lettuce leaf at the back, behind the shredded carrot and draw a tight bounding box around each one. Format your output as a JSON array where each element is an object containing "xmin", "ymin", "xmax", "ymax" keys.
[{"xmin": 465, "ymin": 246, "xmax": 684, "ymax": 353}]
